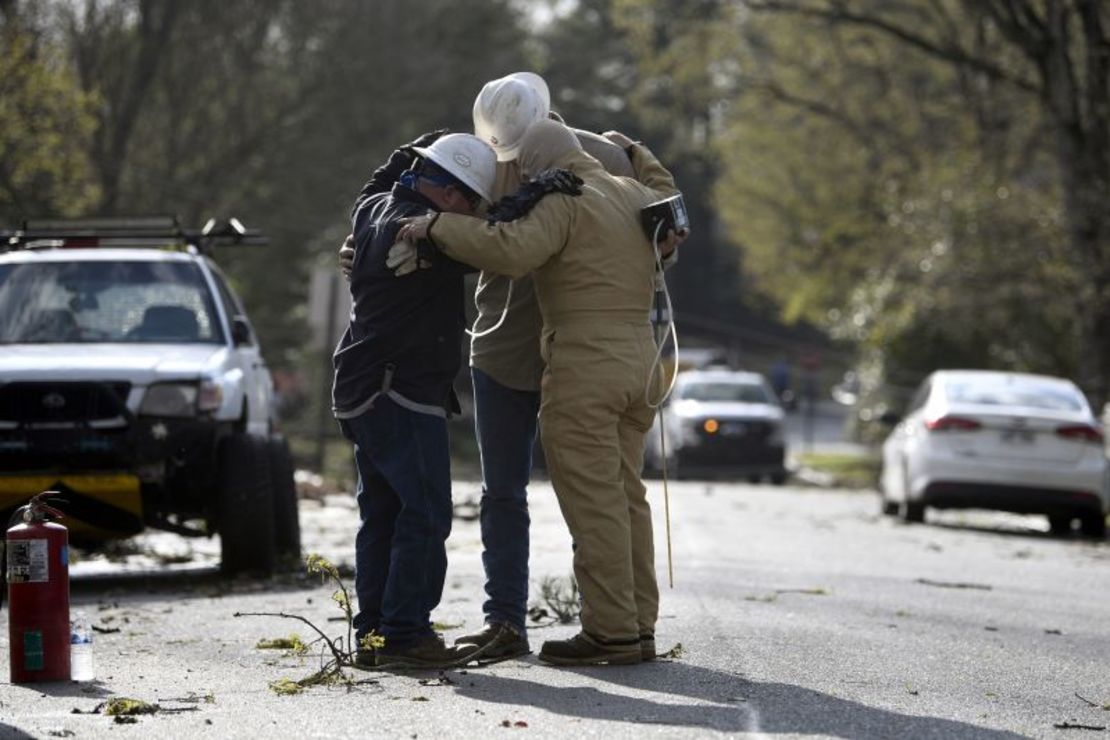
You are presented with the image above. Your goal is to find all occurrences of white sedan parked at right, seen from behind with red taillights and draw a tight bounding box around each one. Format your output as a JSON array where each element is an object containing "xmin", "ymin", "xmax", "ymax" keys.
[{"xmin": 879, "ymin": 371, "xmax": 1110, "ymax": 538}]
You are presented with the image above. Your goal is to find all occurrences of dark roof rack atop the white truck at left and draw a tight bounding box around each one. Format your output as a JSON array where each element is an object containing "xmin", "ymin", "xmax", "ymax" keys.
[{"xmin": 0, "ymin": 216, "xmax": 270, "ymax": 254}]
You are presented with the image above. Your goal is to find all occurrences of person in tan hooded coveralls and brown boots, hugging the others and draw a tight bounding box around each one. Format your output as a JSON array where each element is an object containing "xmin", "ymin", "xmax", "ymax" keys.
[{"xmin": 401, "ymin": 121, "xmax": 677, "ymax": 665}]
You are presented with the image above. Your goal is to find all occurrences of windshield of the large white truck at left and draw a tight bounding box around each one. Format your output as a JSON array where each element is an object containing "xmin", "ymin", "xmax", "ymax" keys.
[{"xmin": 0, "ymin": 261, "xmax": 223, "ymax": 344}]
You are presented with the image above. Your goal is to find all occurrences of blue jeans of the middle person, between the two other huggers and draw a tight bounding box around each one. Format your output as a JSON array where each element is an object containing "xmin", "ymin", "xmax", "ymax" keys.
[{"xmin": 471, "ymin": 367, "xmax": 539, "ymax": 633}]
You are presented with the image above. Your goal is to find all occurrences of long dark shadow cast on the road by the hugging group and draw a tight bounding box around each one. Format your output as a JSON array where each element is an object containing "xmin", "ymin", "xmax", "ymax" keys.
[{"xmin": 456, "ymin": 661, "xmax": 1022, "ymax": 740}]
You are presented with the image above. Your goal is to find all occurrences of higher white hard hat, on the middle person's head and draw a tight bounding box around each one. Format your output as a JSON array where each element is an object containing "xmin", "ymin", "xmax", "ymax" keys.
[{"xmin": 474, "ymin": 72, "xmax": 552, "ymax": 162}]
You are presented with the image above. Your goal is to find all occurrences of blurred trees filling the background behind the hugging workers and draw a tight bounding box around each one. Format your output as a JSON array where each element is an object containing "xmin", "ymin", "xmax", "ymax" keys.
[{"xmin": 0, "ymin": 0, "xmax": 1110, "ymax": 459}]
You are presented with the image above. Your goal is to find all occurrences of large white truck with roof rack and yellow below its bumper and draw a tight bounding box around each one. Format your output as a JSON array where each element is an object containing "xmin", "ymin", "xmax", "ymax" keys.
[{"xmin": 0, "ymin": 219, "xmax": 300, "ymax": 572}]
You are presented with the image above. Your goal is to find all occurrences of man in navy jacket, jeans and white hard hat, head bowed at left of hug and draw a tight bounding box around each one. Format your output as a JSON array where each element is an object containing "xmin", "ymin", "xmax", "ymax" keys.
[{"xmin": 332, "ymin": 134, "xmax": 496, "ymax": 668}]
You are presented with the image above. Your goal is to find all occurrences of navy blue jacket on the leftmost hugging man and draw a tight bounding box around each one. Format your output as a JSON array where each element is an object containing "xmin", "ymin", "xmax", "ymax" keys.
[{"xmin": 332, "ymin": 179, "xmax": 473, "ymax": 417}]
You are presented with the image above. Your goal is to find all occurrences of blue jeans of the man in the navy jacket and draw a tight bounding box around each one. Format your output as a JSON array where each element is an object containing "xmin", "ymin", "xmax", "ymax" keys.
[{"xmin": 340, "ymin": 396, "xmax": 452, "ymax": 648}]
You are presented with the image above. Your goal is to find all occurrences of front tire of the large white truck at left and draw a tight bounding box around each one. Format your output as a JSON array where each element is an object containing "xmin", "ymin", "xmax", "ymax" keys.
[{"xmin": 215, "ymin": 434, "xmax": 275, "ymax": 576}]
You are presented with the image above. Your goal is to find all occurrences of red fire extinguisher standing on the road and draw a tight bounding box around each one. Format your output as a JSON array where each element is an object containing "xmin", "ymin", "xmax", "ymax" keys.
[{"xmin": 7, "ymin": 490, "xmax": 70, "ymax": 683}]
